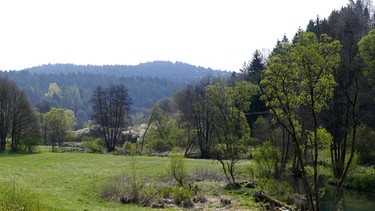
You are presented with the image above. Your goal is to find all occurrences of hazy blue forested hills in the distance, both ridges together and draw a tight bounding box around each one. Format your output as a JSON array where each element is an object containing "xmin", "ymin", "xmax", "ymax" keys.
[{"xmin": 0, "ymin": 62, "xmax": 229, "ymax": 127}]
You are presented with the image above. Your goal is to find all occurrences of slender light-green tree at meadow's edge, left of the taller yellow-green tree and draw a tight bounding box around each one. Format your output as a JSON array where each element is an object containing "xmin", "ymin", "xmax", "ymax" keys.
[{"xmin": 205, "ymin": 81, "xmax": 258, "ymax": 188}]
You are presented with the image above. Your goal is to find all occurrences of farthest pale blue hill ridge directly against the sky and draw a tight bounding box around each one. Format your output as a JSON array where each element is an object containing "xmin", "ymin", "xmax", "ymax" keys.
[{"xmin": 25, "ymin": 61, "xmax": 229, "ymax": 83}]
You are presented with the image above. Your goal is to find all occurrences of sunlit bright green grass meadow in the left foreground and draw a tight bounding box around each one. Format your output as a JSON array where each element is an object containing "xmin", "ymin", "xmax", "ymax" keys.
[{"xmin": 0, "ymin": 149, "xmax": 234, "ymax": 210}]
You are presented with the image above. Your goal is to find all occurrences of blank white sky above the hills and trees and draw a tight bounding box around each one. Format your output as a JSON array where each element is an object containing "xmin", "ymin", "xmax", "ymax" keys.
[{"xmin": 0, "ymin": 0, "xmax": 349, "ymax": 71}]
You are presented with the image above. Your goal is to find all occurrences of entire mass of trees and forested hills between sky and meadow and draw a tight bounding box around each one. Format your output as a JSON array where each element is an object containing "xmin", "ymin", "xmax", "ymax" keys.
[{"xmin": 0, "ymin": 0, "xmax": 375, "ymax": 210}]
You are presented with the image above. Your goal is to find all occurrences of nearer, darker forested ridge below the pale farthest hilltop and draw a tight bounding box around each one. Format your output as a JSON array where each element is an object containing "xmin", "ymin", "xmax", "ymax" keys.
[{"xmin": 0, "ymin": 72, "xmax": 183, "ymax": 127}]
